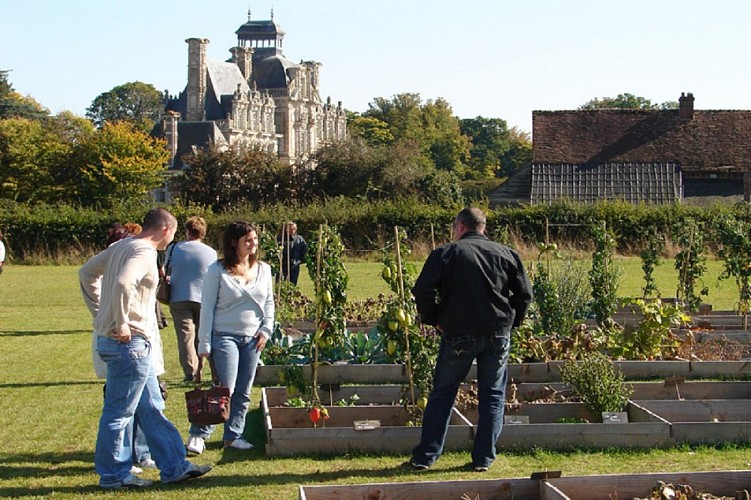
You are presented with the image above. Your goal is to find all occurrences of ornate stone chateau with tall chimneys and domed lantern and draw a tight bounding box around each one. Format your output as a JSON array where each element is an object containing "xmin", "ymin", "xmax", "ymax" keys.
[{"xmin": 154, "ymin": 11, "xmax": 347, "ymax": 170}]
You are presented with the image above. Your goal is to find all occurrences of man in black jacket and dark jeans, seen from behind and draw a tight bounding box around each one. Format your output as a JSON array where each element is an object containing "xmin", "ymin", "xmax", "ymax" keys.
[{"xmin": 410, "ymin": 208, "xmax": 532, "ymax": 472}]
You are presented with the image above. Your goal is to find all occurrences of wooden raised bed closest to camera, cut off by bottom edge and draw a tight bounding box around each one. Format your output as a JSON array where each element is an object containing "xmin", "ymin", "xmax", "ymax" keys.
[{"xmin": 300, "ymin": 471, "xmax": 751, "ymax": 500}]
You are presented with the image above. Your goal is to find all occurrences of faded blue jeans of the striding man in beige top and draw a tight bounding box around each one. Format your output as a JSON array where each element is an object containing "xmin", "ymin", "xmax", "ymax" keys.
[{"xmin": 94, "ymin": 336, "xmax": 190, "ymax": 487}]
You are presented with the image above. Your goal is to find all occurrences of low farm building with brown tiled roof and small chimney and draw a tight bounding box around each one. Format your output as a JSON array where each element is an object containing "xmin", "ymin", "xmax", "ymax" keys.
[{"xmin": 496, "ymin": 93, "xmax": 751, "ymax": 203}]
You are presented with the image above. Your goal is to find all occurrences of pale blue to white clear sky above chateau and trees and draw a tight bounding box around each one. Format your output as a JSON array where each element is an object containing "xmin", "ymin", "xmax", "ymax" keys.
[{"xmin": 0, "ymin": 0, "xmax": 751, "ymax": 132}]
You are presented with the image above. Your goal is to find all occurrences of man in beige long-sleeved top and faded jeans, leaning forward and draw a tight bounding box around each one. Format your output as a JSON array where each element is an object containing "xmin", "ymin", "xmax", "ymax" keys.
[{"xmin": 78, "ymin": 208, "xmax": 211, "ymax": 489}]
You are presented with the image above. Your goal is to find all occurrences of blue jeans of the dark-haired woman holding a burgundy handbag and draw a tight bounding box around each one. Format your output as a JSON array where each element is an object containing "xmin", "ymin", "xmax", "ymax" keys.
[{"xmin": 190, "ymin": 333, "xmax": 261, "ymax": 442}]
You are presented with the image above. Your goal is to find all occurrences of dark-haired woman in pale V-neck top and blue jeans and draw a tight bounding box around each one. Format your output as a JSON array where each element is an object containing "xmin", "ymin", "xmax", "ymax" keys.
[{"xmin": 186, "ymin": 221, "xmax": 274, "ymax": 454}]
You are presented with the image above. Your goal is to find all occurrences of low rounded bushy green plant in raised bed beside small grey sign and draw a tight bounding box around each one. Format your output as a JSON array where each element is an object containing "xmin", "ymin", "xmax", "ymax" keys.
[{"xmin": 561, "ymin": 352, "xmax": 633, "ymax": 413}]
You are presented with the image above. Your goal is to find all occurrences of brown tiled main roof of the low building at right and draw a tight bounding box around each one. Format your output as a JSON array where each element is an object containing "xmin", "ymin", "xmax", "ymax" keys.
[{"xmin": 532, "ymin": 109, "xmax": 751, "ymax": 172}]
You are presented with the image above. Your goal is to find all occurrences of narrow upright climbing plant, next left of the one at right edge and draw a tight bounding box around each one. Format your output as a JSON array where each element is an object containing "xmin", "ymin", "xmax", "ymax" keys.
[{"xmin": 673, "ymin": 220, "xmax": 709, "ymax": 312}]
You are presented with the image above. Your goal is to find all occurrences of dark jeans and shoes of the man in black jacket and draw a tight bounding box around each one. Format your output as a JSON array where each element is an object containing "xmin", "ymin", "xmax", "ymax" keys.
[{"xmin": 412, "ymin": 331, "xmax": 511, "ymax": 467}]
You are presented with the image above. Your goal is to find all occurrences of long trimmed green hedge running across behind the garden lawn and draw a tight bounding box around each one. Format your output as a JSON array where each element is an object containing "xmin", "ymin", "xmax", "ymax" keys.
[{"xmin": 0, "ymin": 198, "xmax": 751, "ymax": 262}]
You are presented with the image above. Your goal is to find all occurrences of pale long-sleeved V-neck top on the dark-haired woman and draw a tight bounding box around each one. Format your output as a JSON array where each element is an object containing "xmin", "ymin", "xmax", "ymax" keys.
[{"xmin": 198, "ymin": 261, "xmax": 274, "ymax": 354}]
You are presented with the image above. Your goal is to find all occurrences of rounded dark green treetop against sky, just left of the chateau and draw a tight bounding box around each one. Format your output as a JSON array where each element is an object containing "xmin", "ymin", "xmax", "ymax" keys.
[{"xmin": 86, "ymin": 82, "xmax": 164, "ymax": 132}]
